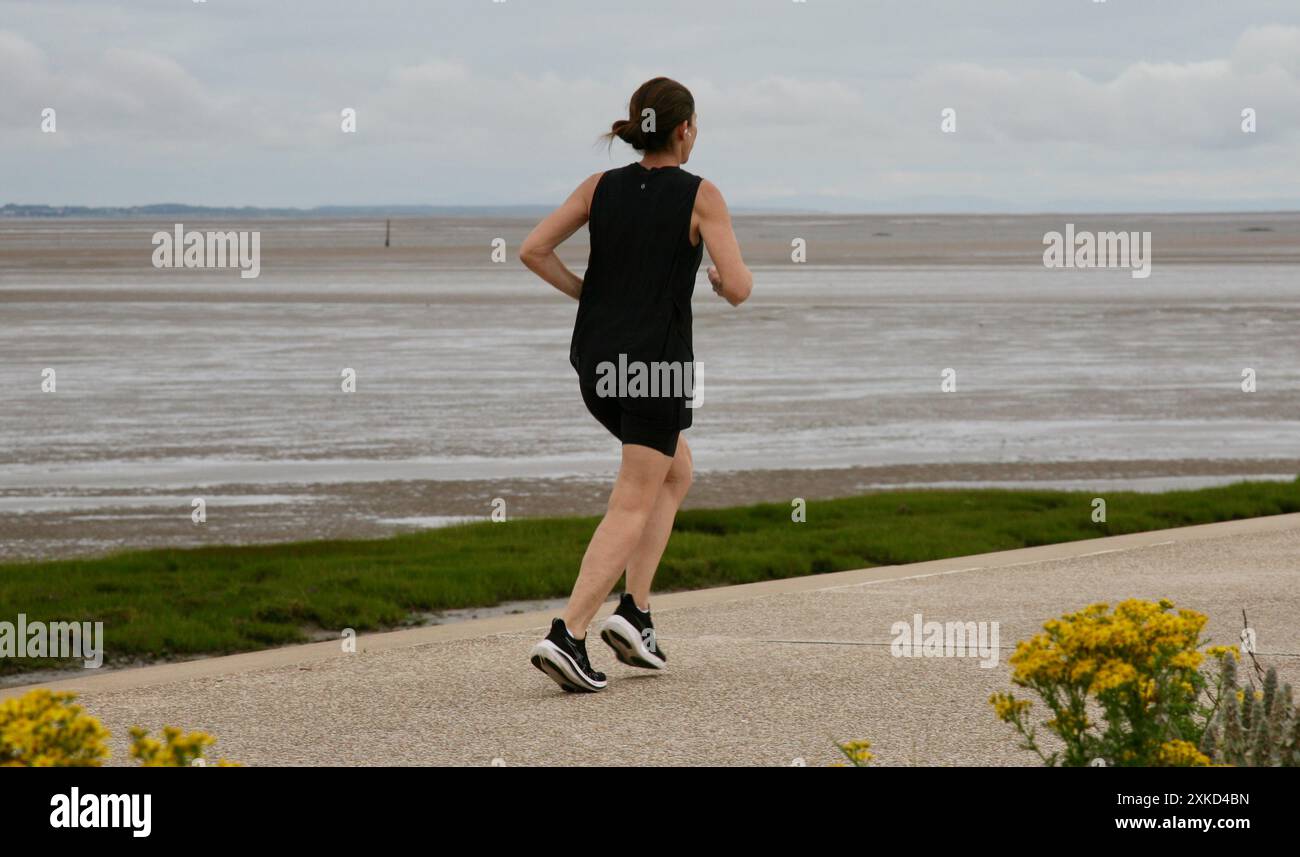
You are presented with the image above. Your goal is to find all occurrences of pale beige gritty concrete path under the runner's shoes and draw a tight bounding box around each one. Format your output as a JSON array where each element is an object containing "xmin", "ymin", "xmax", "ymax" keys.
[{"xmin": 0, "ymin": 515, "xmax": 1300, "ymax": 766}]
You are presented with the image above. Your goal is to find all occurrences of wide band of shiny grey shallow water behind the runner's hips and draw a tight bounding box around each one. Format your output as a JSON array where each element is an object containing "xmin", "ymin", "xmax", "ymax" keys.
[{"xmin": 0, "ymin": 265, "xmax": 1300, "ymax": 489}]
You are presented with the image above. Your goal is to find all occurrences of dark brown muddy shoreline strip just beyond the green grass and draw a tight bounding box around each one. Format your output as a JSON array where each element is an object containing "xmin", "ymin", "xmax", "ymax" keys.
[{"xmin": 0, "ymin": 456, "xmax": 1300, "ymax": 562}]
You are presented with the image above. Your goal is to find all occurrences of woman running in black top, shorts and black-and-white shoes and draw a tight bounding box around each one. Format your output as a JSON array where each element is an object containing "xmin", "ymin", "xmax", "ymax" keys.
[{"xmin": 519, "ymin": 77, "xmax": 754, "ymax": 692}]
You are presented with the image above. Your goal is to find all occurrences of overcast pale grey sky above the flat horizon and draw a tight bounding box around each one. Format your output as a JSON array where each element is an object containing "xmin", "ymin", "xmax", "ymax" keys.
[{"xmin": 0, "ymin": 0, "xmax": 1300, "ymax": 211}]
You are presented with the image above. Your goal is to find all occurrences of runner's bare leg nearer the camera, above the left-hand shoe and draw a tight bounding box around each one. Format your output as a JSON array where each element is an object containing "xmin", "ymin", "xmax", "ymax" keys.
[{"xmin": 563, "ymin": 443, "xmax": 673, "ymax": 640}]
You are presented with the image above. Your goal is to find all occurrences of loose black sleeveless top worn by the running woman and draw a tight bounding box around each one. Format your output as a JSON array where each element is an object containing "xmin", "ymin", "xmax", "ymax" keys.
[{"xmin": 569, "ymin": 164, "xmax": 705, "ymax": 428}]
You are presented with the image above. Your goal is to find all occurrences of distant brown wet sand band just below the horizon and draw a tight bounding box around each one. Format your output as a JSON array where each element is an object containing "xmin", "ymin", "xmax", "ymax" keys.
[{"xmin": 0, "ymin": 212, "xmax": 1300, "ymax": 273}]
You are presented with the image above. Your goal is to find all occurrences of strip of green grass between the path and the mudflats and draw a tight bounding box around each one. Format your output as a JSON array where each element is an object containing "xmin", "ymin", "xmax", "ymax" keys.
[{"xmin": 0, "ymin": 480, "xmax": 1300, "ymax": 674}]
